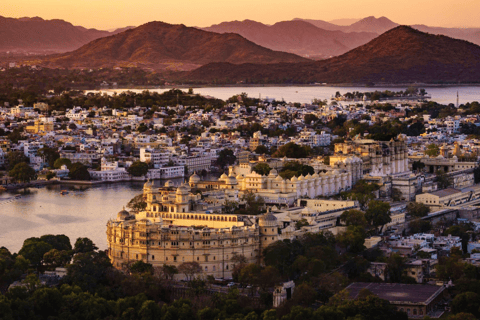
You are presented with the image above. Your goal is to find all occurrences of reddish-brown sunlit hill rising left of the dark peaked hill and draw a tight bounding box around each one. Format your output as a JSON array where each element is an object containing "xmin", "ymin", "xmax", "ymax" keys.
[{"xmin": 40, "ymin": 22, "xmax": 309, "ymax": 71}]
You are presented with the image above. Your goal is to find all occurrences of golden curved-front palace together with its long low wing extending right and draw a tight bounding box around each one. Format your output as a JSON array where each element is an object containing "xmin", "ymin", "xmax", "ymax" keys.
[{"xmin": 107, "ymin": 181, "xmax": 366, "ymax": 278}]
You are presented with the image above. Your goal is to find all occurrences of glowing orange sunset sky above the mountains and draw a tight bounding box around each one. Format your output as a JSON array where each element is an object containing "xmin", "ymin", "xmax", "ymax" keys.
[{"xmin": 0, "ymin": 0, "xmax": 480, "ymax": 29}]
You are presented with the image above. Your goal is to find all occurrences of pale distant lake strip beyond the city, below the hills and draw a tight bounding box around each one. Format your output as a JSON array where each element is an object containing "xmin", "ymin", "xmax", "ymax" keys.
[{"xmin": 89, "ymin": 86, "xmax": 480, "ymax": 104}]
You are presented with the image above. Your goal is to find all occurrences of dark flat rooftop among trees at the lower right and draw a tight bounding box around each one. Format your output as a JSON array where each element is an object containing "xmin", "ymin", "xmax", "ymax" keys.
[{"xmin": 347, "ymin": 282, "xmax": 445, "ymax": 304}]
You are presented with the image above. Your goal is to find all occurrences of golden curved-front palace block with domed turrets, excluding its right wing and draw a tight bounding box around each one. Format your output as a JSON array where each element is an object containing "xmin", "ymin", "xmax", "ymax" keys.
[{"xmin": 107, "ymin": 181, "xmax": 261, "ymax": 278}]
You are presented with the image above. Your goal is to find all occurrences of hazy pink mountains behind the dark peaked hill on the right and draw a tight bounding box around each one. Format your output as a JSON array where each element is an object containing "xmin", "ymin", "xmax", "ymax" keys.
[{"xmin": 204, "ymin": 16, "xmax": 480, "ymax": 59}]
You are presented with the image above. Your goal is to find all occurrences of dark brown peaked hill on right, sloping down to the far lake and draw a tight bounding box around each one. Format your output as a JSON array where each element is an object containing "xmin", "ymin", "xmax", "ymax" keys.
[{"xmin": 181, "ymin": 26, "xmax": 480, "ymax": 84}]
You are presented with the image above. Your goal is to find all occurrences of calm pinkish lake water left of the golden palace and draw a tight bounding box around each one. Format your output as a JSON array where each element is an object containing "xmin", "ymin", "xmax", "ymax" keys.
[{"xmin": 0, "ymin": 179, "xmax": 181, "ymax": 252}]
